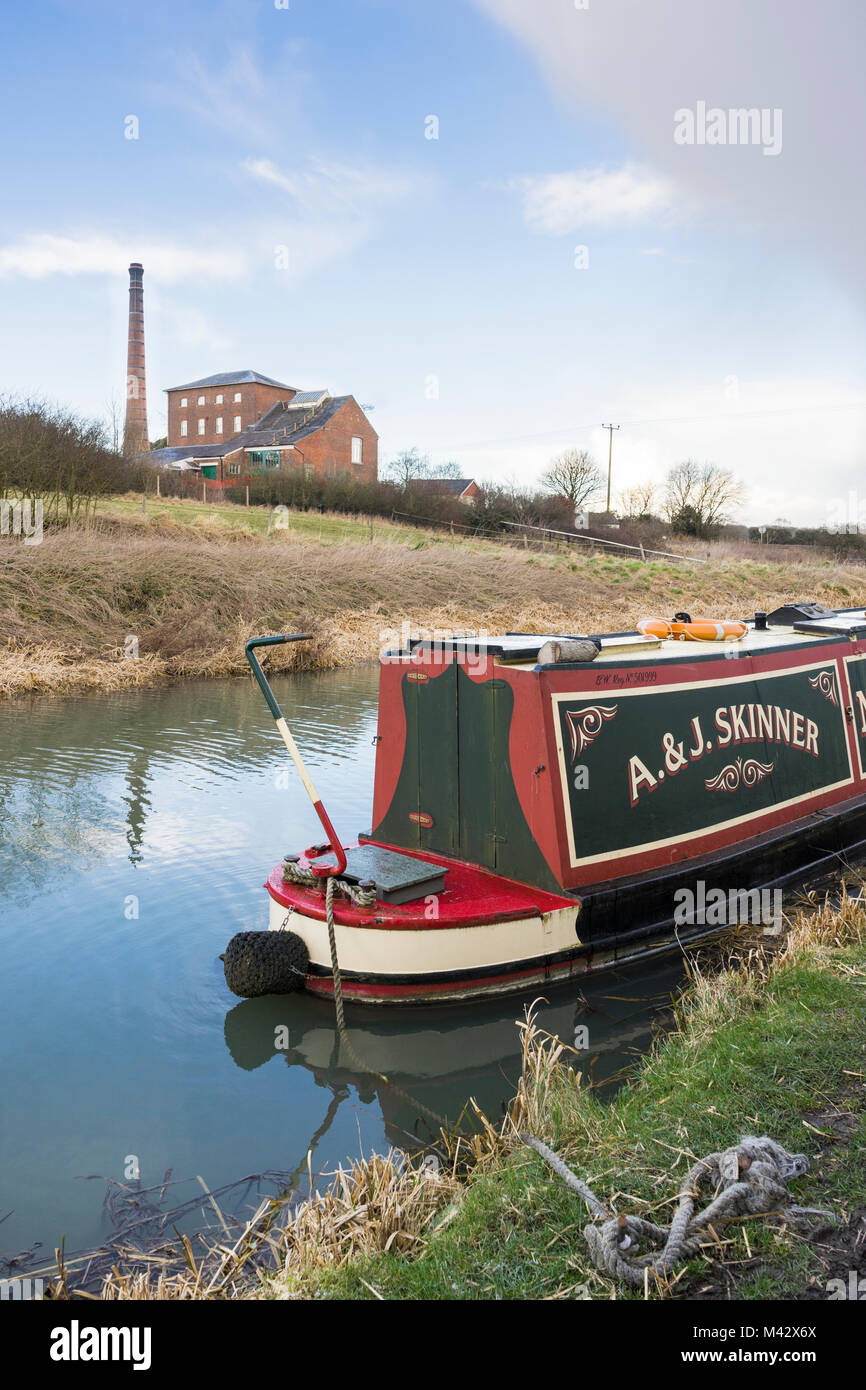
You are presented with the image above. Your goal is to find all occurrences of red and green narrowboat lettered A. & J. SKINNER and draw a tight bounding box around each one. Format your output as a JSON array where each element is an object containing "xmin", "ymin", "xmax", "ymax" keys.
[{"xmin": 225, "ymin": 602, "xmax": 866, "ymax": 1004}]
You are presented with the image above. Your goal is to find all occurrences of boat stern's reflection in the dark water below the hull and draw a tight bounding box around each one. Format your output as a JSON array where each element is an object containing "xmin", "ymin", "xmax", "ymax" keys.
[{"xmin": 225, "ymin": 959, "xmax": 684, "ymax": 1150}]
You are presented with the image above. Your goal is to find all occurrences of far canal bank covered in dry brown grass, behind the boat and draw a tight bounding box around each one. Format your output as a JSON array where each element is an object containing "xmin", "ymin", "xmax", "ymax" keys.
[{"xmin": 0, "ymin": 499, "xmax": 866, "ymax": 695}]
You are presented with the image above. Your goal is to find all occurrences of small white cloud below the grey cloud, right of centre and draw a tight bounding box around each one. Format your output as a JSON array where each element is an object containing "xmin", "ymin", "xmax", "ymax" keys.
[{"xmin": 509, "ymin": 164, "xmax": 676, "ymax": 236}]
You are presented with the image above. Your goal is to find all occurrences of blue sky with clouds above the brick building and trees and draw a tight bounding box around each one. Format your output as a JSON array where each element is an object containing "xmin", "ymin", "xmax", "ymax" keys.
[{"xmin": 0, "ymin": 0, "xmax": 866, "ymax": 525}]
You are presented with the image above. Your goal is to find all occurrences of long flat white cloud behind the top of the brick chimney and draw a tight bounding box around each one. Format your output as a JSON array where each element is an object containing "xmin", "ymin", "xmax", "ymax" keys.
[{"xmin": 0, "ymin": 232, "xmax": 249, "ymax": 284}]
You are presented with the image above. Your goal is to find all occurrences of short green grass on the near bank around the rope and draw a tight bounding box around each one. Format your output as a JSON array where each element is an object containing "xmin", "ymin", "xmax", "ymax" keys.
[{"xmin": 278, "ymin": 922, "xmax": 866, "ymax": 1300}]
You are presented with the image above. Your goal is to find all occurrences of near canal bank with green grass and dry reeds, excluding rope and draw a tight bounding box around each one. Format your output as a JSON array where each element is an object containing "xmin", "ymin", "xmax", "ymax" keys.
[{"xmin": 48, "ymin": 897, "xmax": 866, "ymax": 1300}]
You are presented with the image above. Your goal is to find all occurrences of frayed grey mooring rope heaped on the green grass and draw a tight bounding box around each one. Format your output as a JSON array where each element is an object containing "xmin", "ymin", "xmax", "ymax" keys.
[{"xmin": 520, "ymin": 1134, "xmax": 833, "ymax": 1287}]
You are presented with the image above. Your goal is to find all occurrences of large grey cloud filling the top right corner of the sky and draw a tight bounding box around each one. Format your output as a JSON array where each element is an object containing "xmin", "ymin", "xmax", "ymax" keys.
[{"xmin": 474, "ymin": 0, "xmax": 866, "ymax": 304}]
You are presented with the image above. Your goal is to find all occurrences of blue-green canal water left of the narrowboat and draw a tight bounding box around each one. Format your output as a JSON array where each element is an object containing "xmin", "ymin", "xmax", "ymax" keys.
[{"xmin": 0, "ymin": 667, "xmax": 681, "ymax": 1273}]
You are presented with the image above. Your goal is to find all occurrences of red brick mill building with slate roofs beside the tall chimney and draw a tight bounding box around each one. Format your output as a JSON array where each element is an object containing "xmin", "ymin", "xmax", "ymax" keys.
[{"xmin": 150, "ymin": 371, "xmax": 378, "ymax": 485}]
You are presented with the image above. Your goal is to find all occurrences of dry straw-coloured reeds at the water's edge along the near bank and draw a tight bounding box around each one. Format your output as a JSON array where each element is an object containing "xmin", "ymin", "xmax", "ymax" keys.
[{"xmin": 35, "ymin": 1009, "xmax": 574, "ymax": 1300}]
